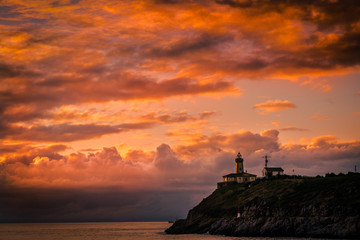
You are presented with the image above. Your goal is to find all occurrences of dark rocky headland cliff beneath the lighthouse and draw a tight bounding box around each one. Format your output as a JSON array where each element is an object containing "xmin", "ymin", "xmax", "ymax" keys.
[{"xmin": 166, "ymin": 173, "xmax": 360, "ymax": 239}]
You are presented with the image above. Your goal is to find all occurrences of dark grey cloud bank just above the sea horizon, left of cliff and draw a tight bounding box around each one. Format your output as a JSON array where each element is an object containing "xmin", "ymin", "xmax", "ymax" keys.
[{"xmin": 0, "ymin": 187, "xmax": 205, "ymax": 222}]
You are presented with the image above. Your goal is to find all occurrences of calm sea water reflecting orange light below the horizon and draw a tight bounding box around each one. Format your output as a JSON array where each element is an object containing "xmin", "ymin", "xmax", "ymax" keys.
[{"xmin": 0, "ymin": 222, "xmax": 310, "ymax": 240}]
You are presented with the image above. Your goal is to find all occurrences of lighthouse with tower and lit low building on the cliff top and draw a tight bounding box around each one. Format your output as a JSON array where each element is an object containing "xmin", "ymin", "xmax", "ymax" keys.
[{"xmin": 217, "ymin": 153, "xmax": 256, "ymax": 188}]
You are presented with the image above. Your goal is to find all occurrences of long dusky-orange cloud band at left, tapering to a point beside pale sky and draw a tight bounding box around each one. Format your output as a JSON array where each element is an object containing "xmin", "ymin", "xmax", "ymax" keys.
[{"xmin": 1, "ymin": 74, "xmax": 237, "ymax": 119}]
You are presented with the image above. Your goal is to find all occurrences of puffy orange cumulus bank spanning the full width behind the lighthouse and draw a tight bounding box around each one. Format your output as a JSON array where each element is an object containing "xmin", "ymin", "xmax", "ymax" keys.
[{"xmin": 0, "ymin": 130, "xmax": 360, "ymax": 189}]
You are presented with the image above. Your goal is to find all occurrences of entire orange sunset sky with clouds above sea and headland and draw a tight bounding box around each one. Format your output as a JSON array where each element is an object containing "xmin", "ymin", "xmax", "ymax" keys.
[{"xmin": 0, "ymin": 0, "xmax": 360, "ymax": 222}]
